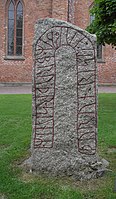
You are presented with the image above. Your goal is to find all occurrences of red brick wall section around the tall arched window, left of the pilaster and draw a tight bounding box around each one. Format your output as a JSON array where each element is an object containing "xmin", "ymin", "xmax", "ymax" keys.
[{"xmin": 0, "ymin": 0, "xmax": 52, "ymax": 82}]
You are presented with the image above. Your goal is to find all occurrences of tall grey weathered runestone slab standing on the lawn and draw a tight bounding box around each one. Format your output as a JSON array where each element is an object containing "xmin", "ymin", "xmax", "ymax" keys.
[{"xmin": 31, "ymin": 19, "xmax": 106, "ymax": 179}]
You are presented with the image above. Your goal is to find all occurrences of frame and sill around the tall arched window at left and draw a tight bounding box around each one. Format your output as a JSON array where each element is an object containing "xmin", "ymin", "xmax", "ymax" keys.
[{"xmin": 5, "ymin": 0, "xmax": 25, "ymax": 60}]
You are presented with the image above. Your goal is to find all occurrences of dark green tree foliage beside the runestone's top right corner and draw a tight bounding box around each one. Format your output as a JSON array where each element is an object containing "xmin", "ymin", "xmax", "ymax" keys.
[{"xmin": 87, "ymin": 0, "xmax": 116, "ymax": 46}]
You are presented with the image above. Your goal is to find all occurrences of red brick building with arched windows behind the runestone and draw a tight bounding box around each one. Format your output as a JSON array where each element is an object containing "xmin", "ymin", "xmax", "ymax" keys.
[{"xmin": 0, "ymin": 0, "xmax": 116, "ymax": 84}]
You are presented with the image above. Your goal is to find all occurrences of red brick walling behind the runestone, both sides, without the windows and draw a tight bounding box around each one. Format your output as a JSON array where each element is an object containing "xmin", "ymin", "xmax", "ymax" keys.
[{"xmin": 0, "ymin": 0, "xmax": 116, "ymax": 84}]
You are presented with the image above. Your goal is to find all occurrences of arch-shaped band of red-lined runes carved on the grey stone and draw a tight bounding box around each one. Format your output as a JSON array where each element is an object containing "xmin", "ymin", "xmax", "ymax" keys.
[{"xmin": 33, "ymin": 25, "xmax": 97, "ymax": 155}]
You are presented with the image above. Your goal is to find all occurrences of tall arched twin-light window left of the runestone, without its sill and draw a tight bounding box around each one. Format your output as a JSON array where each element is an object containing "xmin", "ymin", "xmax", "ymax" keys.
[{"xmin": 7, "ymin": 0, "xmax": 23, "ymax": 56}]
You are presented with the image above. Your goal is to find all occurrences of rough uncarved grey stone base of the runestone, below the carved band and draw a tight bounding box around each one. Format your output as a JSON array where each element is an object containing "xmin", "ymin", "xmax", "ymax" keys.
[{"xmin": 23, "ymin": 151, "xmax": 109, "ymax": 180}]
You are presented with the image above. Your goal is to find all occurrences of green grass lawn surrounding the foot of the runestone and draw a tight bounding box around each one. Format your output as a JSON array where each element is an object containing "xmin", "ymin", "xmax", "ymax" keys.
[{"xmin": 0, "ymin": 94, "xmax": 116, "ymax": 199}]
